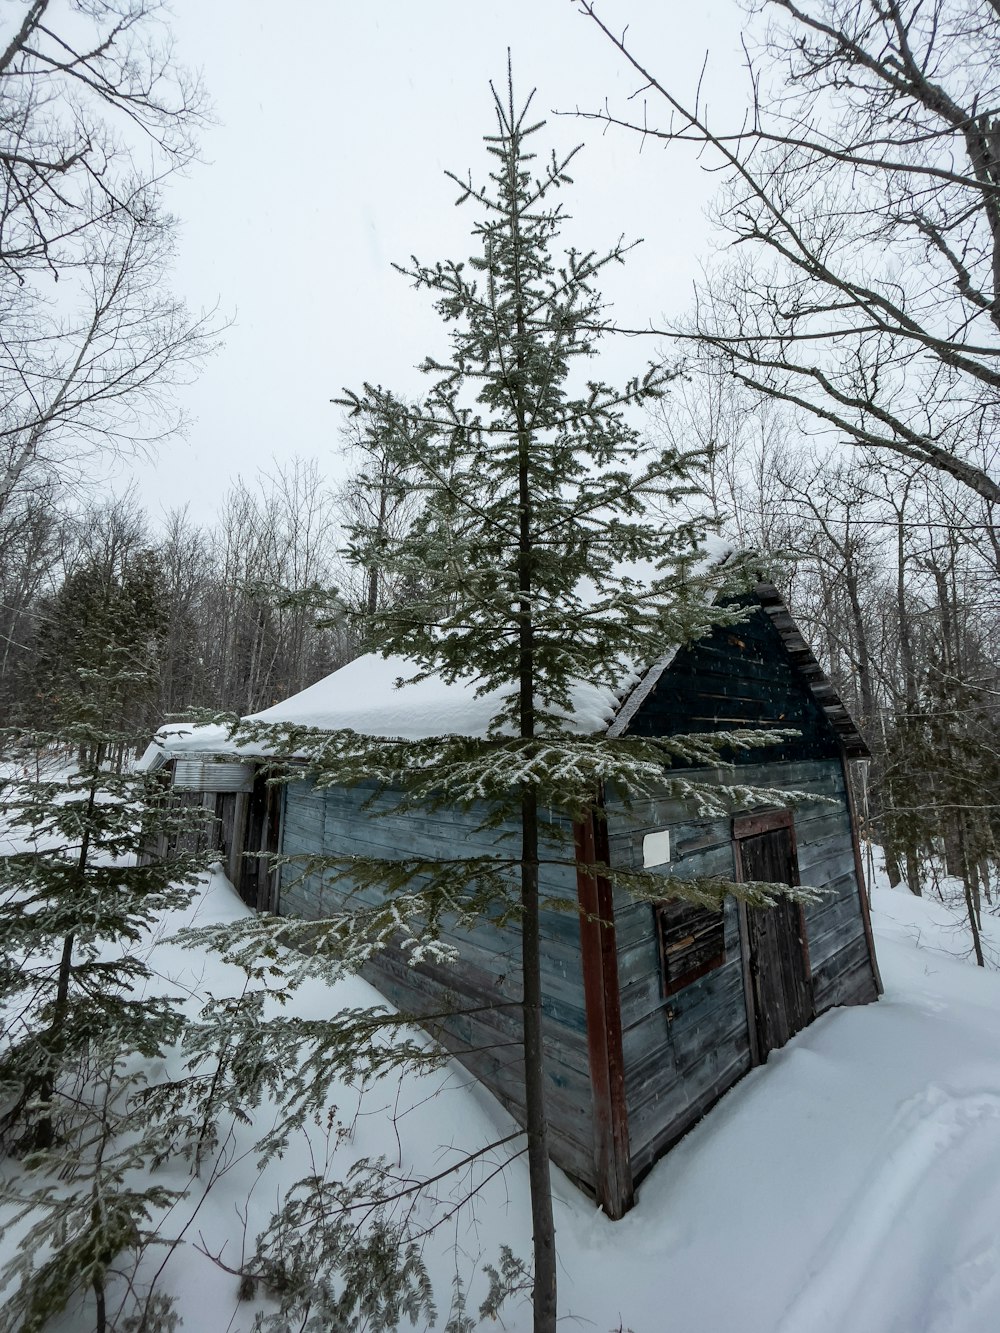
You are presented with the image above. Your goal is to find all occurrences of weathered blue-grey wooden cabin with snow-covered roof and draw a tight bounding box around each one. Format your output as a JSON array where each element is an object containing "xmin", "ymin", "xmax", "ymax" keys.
[{"xmin": 144, "ymin": 583, "xmax": 881, "ymax": 1217}]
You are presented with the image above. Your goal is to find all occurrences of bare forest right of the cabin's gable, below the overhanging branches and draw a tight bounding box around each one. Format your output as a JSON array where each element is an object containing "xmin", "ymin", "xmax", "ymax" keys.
[{"xmin": 653, "ymin": 361, "xmax": 1000, "ymax": 938}]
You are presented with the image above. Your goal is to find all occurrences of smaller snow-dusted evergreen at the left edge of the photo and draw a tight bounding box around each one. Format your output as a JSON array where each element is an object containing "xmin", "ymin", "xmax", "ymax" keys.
[{"xmin": 0, "ymin": 615, "xmax": 204, "ymax": 1333}]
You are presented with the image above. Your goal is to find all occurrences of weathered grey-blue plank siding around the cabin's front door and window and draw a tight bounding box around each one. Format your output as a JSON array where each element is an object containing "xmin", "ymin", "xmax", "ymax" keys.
[{"xmin": 608, "ymin": 758, "xmax": 875, "ymax": 1174}]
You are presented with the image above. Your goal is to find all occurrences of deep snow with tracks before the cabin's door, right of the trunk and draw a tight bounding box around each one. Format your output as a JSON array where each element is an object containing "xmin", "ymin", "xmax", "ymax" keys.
[{"xmin": 570, "ymin": 874, "xmax": 1000, "ymax": 1333}]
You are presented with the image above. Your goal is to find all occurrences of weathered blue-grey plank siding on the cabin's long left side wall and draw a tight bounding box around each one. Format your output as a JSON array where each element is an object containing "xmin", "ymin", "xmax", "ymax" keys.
[{"xmin": 279, "ymin": 782, "xmax": 595, "ymax": 1188}]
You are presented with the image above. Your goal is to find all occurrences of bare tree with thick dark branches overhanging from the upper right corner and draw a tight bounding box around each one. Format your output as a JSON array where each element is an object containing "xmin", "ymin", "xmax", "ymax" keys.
[{"xmin": 576, "ymin": 0, "xmax": 1000, "ymax": 505}]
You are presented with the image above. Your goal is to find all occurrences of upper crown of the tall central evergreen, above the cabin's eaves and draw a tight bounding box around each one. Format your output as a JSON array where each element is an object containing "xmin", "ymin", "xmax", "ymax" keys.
[{"xmin": 343, "ymin": 76, "xmax": 717, "ymax": 737}]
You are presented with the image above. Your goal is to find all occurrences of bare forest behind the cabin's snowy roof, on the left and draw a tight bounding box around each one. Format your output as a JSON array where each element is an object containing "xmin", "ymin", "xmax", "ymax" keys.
[{"xmin": 0, "ymin": 461, "xmax": 351, "ymax": 742}]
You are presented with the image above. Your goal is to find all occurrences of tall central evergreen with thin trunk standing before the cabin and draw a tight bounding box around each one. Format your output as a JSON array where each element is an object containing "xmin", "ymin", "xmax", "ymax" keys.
[{"xmin": 197, "ymin": 80, "xmax": 816, "ymax": 1333}]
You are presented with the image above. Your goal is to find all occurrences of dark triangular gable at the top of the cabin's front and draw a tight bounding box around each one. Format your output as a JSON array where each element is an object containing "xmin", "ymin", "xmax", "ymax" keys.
[{"xmin": 628, "ymin": 599, "xmax": 840, "ymax": 762}]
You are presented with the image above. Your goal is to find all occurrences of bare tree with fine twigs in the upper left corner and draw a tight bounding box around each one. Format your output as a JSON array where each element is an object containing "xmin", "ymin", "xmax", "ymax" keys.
[{"xmin": 0, "ymin": 0, "xmax": 215, "ymax": 520}]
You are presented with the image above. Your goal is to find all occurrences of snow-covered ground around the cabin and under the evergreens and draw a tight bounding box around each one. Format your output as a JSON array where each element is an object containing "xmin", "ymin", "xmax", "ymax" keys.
[{"xmin": 0, "ymin": 826, "xmax": 1000, "ymax": 1333}]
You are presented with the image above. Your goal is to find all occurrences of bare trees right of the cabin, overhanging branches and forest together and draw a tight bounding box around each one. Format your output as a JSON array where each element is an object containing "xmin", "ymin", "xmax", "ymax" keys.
[{"xmin": 565, "ymin": 0, "xmax": 1000, "ymax": 938}]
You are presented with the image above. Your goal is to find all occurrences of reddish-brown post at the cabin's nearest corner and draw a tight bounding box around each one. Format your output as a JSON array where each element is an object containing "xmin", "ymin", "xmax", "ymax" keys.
[{"xmin": 573, "ymin": 799, "xmax": 633, "ymax": 1221}]
